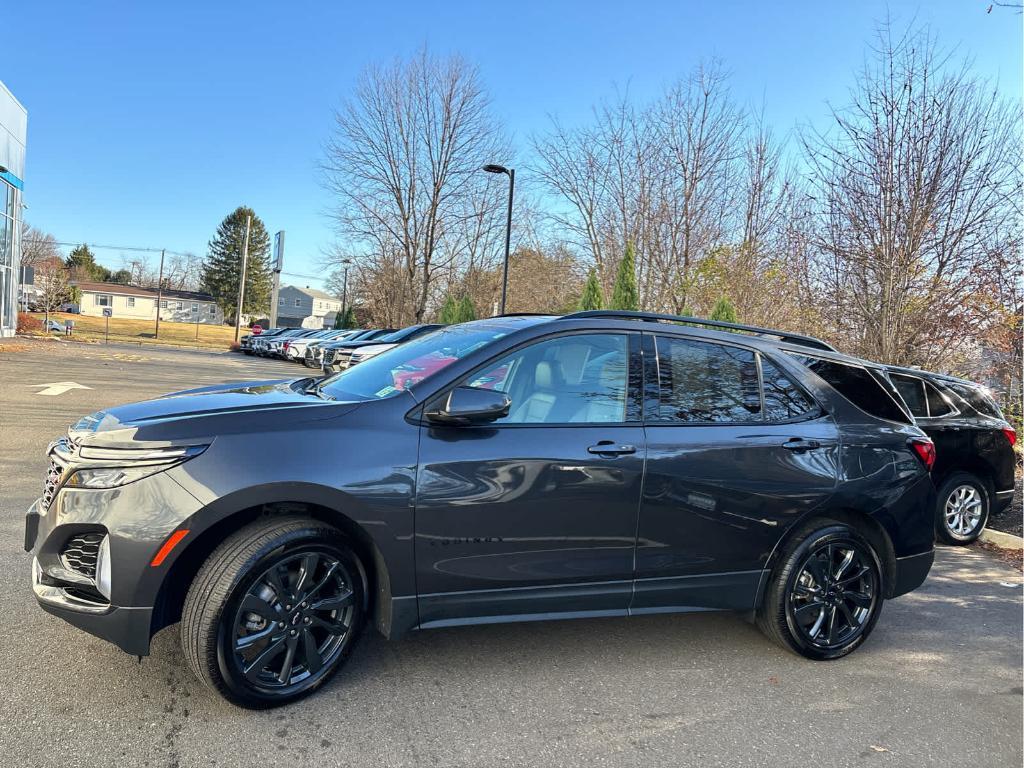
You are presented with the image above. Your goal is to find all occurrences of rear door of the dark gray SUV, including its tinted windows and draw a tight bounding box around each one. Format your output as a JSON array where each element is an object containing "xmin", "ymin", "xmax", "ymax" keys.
[{"xmin": 631, "ymin": 334, "xmax": 839, "ymax": 612}]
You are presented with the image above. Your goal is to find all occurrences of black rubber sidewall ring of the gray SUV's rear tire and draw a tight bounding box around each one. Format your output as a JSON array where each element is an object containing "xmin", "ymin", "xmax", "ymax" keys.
[{"xmin": 774, "ymin": 523, "xmax": 885, "ymax": 660}]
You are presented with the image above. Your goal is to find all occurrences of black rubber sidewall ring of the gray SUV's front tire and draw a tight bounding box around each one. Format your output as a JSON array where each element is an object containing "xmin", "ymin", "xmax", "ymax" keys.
[{"xmin": 215, "ymin": 527, "xmax": 366, "ymax": 709}]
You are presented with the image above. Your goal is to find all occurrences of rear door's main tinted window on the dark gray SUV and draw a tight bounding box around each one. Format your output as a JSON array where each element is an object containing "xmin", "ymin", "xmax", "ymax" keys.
[{"xmin": 647, "ymin": 336, "xmax": 762, "ymax": 424}]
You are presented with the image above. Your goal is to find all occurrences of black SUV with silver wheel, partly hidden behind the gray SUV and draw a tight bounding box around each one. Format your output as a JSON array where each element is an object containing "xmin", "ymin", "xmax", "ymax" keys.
[{"xmin": 888, "ymin": 367, "xmax": 1017, "ymax": 544}]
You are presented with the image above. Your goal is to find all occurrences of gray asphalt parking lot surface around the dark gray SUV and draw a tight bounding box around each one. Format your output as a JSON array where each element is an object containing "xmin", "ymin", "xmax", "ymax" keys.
[{"xmin": 0, "ymin": 343, "xmax": 1024, "ymax": 768}]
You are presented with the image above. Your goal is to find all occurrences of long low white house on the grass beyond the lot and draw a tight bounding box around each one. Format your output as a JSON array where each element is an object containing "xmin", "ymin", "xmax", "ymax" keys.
[{"xmin": 75, "ymin": 281, "xmax": 224, "ymax": 326}]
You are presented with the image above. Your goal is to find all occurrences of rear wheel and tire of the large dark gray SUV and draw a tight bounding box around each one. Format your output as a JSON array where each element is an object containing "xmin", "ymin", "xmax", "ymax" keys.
[{"xmin": 757, "ymin": 520, "xmax": 885, "ymax": 660}]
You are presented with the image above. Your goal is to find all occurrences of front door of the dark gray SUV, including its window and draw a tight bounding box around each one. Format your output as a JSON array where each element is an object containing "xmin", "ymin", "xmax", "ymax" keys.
[{"xmin": 416, "ymin": 333, "xmax": 644, "ymax": 626}]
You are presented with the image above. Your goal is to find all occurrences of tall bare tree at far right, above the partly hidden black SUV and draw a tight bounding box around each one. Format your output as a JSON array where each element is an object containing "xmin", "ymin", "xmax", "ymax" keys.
[{"xmin": 803, "ymin": 27, "xmax": 1021, "ymax": 367}]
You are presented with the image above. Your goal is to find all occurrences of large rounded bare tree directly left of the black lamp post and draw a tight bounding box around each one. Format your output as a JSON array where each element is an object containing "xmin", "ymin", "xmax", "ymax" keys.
[{"xmin": 323, "ymin": 50, "xmax": 509, "ymax": 322}]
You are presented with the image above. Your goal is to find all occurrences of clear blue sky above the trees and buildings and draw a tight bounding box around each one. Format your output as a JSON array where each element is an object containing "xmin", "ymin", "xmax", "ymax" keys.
[{"xmin": 0, "ymin": 0, "xmax": 1022, "ymax": 285}]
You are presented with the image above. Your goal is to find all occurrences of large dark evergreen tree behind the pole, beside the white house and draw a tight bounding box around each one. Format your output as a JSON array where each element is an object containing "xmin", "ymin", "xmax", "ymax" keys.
[{"xmin": 203, "ymin": 206, "xmax": 270, "ymax": 319}]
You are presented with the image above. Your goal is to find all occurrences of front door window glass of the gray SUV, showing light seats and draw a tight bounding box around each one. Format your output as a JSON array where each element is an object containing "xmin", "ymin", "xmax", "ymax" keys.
[{"xmin": 466, "ymin": 334, "xmax": 629, "ymax": 424}]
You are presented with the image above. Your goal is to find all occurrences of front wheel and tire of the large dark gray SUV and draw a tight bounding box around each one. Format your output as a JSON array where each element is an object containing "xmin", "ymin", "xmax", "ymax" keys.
[{"xmin": 181, "ymin": 518, "xmax": 366, "ymax": 710}]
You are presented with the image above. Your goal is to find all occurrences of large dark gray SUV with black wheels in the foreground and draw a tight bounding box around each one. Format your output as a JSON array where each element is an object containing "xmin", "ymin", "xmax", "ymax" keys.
[{"xmin": 26, "ymin": 311, "xmax": 935, "ymax": 708}]
